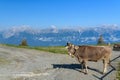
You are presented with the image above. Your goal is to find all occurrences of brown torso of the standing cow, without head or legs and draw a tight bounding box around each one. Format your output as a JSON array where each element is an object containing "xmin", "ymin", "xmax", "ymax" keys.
[{"xmin": 76, "ymin": 46, "xmax": 111, "ymax": 61}]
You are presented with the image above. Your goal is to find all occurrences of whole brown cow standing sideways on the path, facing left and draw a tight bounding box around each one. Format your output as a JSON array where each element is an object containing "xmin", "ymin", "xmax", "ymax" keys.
[{"xmin": 66, "ymin": 43, "xmax": 112, "ymax": 73}]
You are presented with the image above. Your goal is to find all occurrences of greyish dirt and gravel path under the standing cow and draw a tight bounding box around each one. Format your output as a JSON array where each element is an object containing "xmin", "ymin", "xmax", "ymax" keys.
[{"xmin": 0, "ymin": 45, "xmax": 120, "ymax": 80}]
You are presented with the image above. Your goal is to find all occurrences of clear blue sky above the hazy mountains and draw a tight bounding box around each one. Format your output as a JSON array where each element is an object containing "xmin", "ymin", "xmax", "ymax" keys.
[{"xmin": 0, "ymin": 0, "xmax": 120, "ymax": 28}]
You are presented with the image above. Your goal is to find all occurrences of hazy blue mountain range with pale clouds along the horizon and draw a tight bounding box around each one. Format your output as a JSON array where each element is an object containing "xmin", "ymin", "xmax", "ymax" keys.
[{"xmin": 0, "ymin": 25, "xmax": 120, "ymax": 46}]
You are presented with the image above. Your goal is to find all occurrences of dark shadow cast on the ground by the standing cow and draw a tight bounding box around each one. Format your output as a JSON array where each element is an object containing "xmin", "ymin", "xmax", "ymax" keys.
[{"xmin": 52, "ymin": 64, "xmax": 102, "ymax": 74}]
